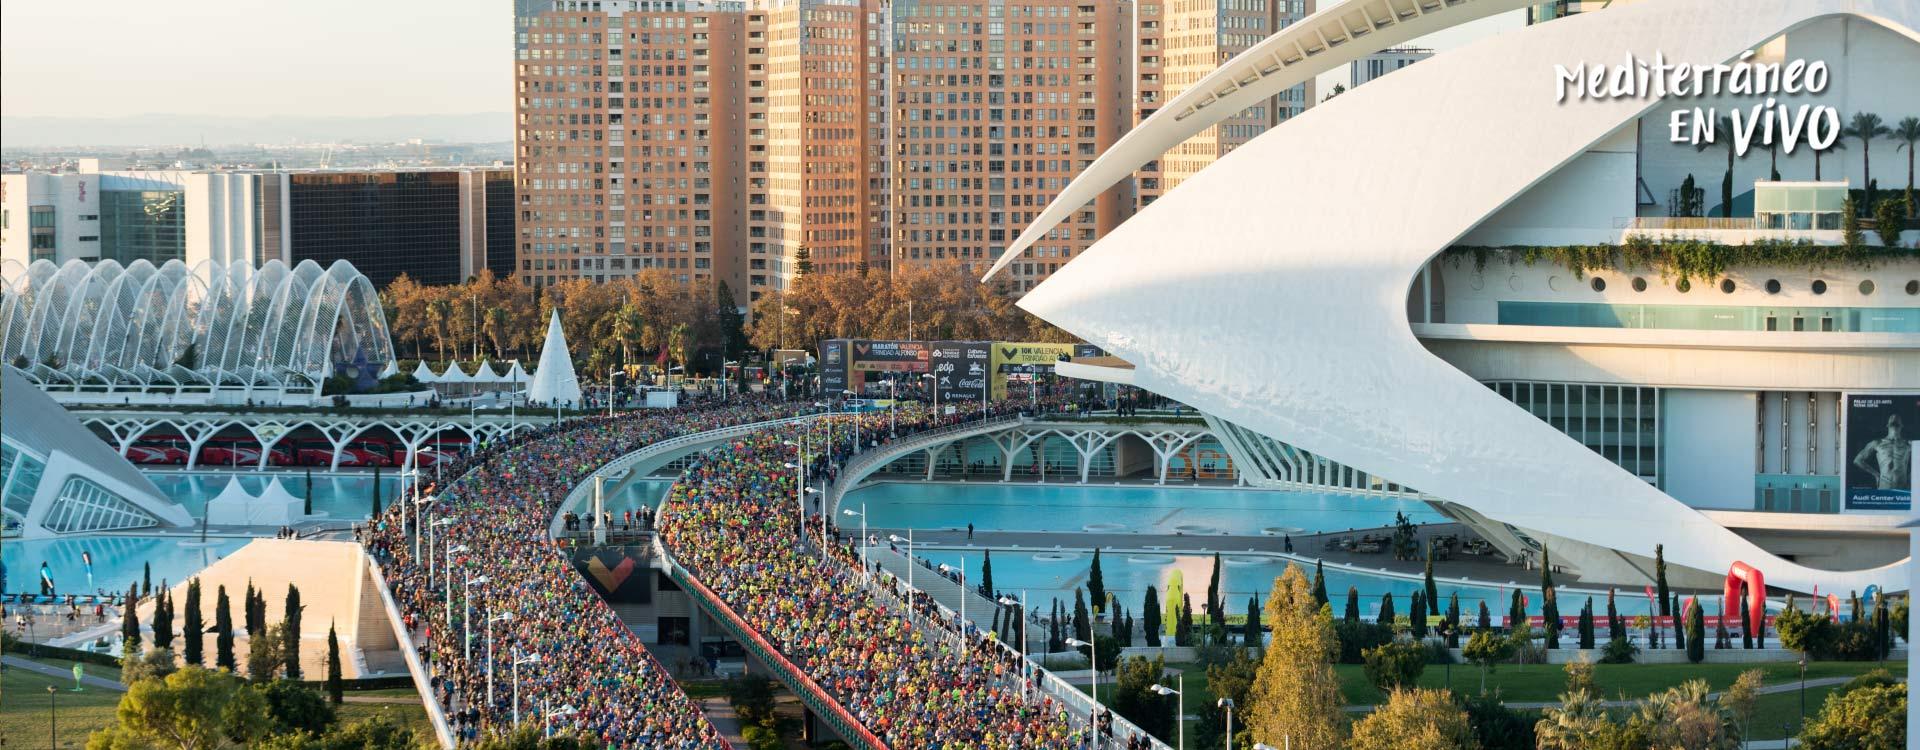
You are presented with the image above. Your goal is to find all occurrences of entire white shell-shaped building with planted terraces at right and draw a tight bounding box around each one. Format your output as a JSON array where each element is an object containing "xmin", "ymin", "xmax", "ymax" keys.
[{"xmin": 996, "ymin": 0, "xmax": 1920, "ymax": 593}]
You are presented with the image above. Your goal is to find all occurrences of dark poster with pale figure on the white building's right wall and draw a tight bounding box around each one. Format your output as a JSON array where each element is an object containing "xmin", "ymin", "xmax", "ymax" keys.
[{"xmin": 1845, "ymin": 393, "xmax": 1920, "ymax": 510}]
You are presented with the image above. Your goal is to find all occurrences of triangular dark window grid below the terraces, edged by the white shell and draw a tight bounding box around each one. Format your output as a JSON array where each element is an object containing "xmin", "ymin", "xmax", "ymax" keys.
[{"xmin": 1486, "ymin": 380, "xmax": 1661, "ymax": 485}]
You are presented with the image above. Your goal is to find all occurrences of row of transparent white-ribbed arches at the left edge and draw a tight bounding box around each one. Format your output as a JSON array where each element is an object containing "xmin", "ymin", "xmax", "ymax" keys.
[{"xmin": 0, "ymin": 261, "xmax": 394, "ymax": 391}]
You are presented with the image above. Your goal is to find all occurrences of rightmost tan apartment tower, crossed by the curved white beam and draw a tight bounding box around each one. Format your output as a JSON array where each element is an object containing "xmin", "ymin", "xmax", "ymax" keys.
[{"xmin": 1133, "ymin": 0, "xmax": 1315, "ymax": 207}]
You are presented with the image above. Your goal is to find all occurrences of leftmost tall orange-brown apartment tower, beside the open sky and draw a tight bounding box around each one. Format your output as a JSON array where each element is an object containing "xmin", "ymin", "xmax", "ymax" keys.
[{"xmin": 515, "ymin": 0, "xmax": 747, "ymax": 301}]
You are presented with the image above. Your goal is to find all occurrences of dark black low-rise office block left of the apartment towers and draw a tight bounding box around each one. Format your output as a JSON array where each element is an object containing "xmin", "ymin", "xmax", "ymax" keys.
[{"xmin": 286, "ymin": 171, "xmax": 464, "ymax": 288}]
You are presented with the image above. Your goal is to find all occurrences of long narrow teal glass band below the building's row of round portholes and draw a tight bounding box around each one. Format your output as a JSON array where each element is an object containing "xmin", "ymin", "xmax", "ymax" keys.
[{"xmin": 1500, "ymin": 301, "xmax": 1920, "ymax": 334}]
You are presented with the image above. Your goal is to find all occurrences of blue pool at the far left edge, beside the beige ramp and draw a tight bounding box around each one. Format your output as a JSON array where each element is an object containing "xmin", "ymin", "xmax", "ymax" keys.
[{"xmin": 0, "ymin": 537, "xmax": 248, "ymax": 595}]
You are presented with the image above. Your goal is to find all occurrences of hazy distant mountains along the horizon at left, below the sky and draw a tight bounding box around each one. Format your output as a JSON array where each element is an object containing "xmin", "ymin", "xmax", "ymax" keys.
[{"xmin": 0, "ymin": 111, "xmax": 513, "ymax": 148}]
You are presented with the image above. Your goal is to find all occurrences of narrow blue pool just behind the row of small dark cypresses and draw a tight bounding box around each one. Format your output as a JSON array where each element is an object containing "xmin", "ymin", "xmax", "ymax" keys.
[{"xmin": 918, "ymin": 549, "xmax": 1681, "ymax": 621}]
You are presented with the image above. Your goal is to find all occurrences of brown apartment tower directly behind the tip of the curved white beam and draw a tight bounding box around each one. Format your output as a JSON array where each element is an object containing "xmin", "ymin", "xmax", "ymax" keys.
[{"xmin": 891, "ymin": 0, "xmax": 1133, "ymax": 293}]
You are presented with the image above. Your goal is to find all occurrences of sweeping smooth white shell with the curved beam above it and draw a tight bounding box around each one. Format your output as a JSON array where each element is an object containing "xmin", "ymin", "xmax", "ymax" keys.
[{"xmin": 995, "ymin": 0, "xmax": 1920, "ymax": 591}]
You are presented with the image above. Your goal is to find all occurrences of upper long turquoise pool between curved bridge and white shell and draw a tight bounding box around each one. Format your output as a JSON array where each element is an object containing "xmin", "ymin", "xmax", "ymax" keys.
[{"xmin": 841, "ymin": 481, "xmax": 1446, "ymax": 537}]
